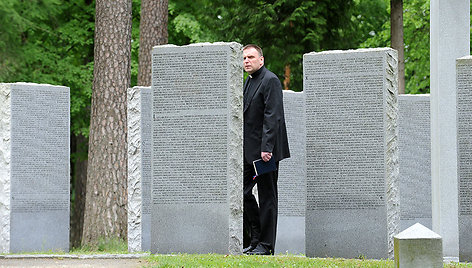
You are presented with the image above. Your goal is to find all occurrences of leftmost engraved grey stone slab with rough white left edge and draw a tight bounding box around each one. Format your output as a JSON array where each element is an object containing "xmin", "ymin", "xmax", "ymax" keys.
[{"xmin": 0, "ymin": 83, "xmax": 70, "ymax": 253}]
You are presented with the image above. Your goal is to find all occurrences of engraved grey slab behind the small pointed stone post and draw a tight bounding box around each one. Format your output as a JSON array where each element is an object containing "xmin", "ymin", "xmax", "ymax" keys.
[{"xmin": 398, "ymin": 94, "xmax": 432, "ymax": 231}]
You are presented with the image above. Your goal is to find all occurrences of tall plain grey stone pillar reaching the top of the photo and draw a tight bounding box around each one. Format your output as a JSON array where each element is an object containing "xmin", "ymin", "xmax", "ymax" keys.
[{"xmin": 430, "ymin": 0, "xmax": 470, "ymax": 261}]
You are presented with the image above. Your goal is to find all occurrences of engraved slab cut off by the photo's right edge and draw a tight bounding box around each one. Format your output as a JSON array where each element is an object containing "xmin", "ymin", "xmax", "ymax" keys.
[{"xmin": 456, "ymin": 56, "xmax": 472, "ymax": 262}]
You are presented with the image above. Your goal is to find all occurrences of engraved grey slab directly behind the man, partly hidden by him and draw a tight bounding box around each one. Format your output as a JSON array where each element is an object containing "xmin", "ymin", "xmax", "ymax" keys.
[{"xmin": 275, "ymin": 90, "xmax": 306, "ymax": 254}]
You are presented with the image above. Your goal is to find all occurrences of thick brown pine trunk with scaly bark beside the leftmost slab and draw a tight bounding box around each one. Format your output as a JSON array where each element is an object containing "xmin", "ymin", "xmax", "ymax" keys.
[{"xmin": 82, "ymin": 0, "xmax": 131, "ymax": 244}]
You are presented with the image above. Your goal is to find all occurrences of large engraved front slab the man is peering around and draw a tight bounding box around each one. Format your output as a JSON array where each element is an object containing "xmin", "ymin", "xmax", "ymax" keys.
[{"xmin": 151, "ymin": 43, "xmax": 243, "ymax": 254}]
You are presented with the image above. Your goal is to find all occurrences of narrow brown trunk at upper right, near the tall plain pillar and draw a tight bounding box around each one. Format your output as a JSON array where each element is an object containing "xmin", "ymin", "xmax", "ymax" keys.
[{"xmin": 390, "ymin": 0, "xmax": 405, "ymax": 94}]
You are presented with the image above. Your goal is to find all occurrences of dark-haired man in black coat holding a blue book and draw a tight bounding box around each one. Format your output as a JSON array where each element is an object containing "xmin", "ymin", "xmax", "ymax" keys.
[{"xmin": 243, "ymin": 44, "xmax": 290, "ymax": 255}]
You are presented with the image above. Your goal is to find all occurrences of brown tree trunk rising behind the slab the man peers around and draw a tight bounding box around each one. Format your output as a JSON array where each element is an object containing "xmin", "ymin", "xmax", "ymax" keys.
[{"xmin": 138, "ymin": 0, "xmax": 169, "ymax": 86}]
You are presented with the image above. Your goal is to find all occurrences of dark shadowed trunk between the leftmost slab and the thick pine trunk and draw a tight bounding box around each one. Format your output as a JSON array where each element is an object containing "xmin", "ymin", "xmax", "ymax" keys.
[{"xmin": 70, "ymin": 135, "xmax": 87, "ymax": 248}]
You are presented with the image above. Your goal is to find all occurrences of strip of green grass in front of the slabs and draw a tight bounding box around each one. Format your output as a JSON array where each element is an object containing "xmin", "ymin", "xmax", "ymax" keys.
[{"xmin": 146, "ymin": 254, "xmax": 472, "ymax": 268}]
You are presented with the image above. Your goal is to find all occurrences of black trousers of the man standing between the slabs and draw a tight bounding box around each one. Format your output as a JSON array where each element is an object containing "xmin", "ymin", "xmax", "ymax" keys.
[{"xmin": 243, "ymin": 161, "xmax": 279, "ymax": 253}]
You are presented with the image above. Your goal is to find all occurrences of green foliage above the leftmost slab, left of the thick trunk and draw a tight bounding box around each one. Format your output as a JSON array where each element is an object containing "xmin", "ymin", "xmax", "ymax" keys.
[{"xmin": 0, "ymin": 0, "xmax": 95, "ymax": 136}]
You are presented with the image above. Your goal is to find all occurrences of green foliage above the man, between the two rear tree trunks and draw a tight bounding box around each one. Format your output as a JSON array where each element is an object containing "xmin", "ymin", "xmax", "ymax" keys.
[{"xmin": 169, "ymin": 0, "xmax": 388, "ymax": 91}]
